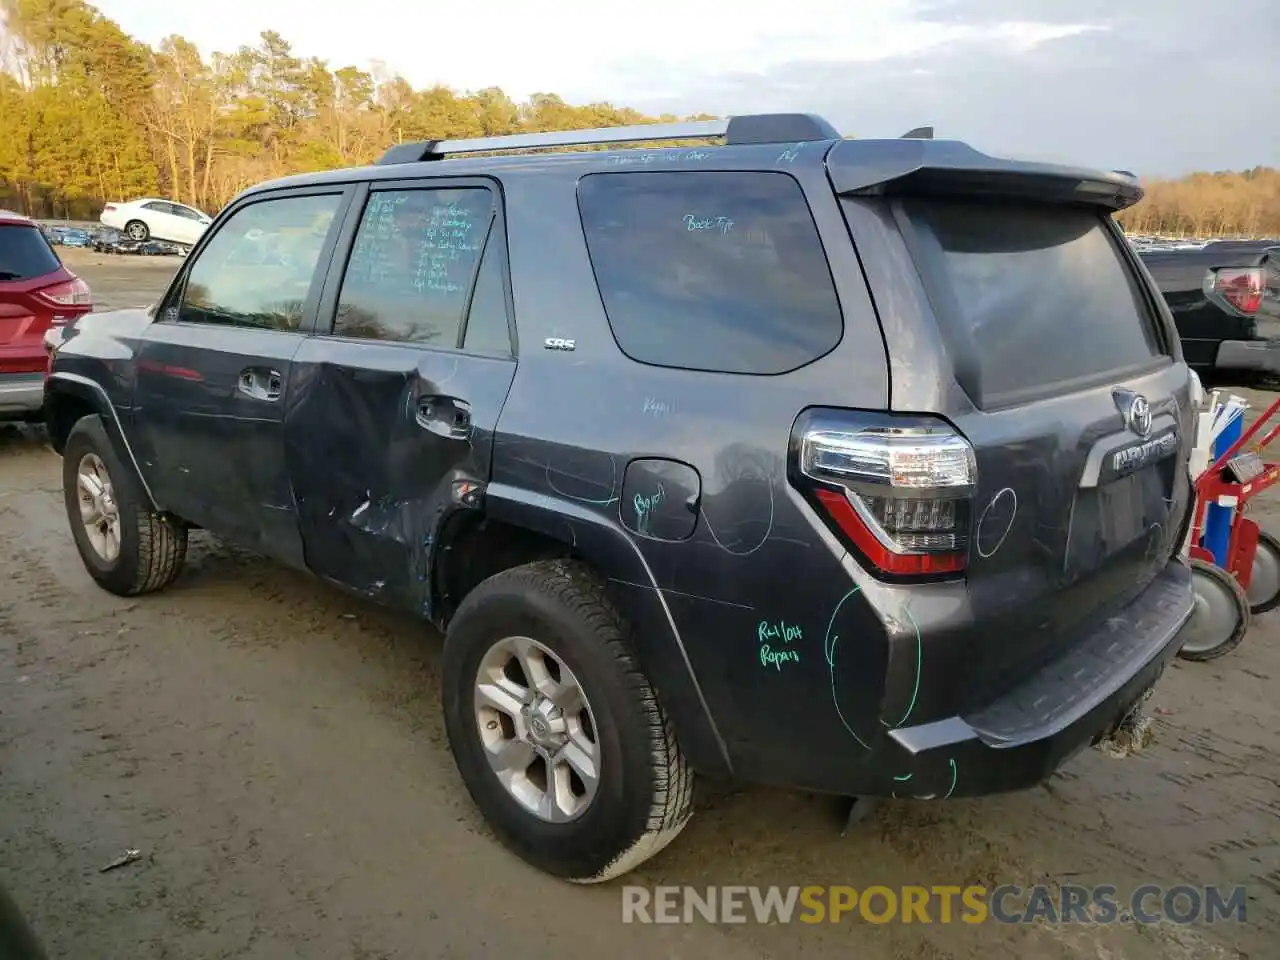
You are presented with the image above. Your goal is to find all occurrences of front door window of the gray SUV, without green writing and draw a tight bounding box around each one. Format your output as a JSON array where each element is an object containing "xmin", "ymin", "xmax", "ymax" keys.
[{"xmin": 178, "ymin": 193, "xmax": 342, "ymax": 330}]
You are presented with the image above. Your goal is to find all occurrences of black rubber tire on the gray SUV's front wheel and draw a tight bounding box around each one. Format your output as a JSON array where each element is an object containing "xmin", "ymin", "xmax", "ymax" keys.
[{"xmin": 63, "ymin": 415, "xmax": 187, "ymax": 596}]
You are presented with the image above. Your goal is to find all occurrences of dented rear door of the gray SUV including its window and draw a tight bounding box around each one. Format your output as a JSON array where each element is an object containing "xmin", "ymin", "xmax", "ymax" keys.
[{"xmin": 284, "ymin": 178, "xmax": 516, "ymax": 614}]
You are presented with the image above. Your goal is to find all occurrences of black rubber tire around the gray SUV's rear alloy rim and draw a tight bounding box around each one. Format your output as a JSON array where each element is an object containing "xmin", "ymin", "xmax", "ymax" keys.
[{"xmin": 442, "ymin": 559, "xmax": 694, "ymax": 883}]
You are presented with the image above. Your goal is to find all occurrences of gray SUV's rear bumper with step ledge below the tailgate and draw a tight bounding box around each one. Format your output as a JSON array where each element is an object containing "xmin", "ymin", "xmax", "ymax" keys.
[{"xmin": 884, "ymin": 562, "xmax": 1193, "ymax": 799}]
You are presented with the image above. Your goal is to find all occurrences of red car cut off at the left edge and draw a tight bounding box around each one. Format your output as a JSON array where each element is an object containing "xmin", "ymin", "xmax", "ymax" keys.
[{"xmin": 0, "ymin": 210, "xmax": 93, "ymax": 420}]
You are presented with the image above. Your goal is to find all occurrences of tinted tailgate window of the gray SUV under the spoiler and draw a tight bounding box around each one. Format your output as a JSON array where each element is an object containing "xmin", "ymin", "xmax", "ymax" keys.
[{"xmin": 905, "ymin": 200, "xmax": 1160, "ymax": 403}]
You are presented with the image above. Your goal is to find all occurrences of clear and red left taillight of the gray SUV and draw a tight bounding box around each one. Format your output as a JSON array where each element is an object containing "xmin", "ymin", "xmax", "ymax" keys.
[{"xmin": 799, "ymin": 419, "xmax": 978, "ymax": 576}]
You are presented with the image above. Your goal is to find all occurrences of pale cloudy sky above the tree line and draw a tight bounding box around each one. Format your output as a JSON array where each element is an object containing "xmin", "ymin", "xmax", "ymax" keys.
[{"xmin": 95, "ymin": 0, "xmax": 1280, "ymax": 177}]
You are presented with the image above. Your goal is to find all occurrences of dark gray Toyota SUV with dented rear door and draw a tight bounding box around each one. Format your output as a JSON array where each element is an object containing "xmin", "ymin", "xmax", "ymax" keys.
[{"xmin": 46, "ymin": 115, "xmax": 1192, "ymax": 881}]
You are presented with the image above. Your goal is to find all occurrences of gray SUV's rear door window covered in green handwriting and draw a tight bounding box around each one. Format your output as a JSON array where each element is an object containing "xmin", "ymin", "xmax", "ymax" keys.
[{"xmin": 333, "ymin": 187, "xmax": 499, "ymax": 349}]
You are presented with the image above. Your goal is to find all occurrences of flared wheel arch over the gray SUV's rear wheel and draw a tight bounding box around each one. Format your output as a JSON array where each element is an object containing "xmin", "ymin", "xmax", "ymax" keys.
[{"xmin": 431, "ymin": 484, "xmax": 732, "ymax": 780}]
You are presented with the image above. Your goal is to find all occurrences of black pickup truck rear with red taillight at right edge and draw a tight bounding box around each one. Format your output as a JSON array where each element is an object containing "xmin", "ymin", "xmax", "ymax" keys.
[{"xmin": 1139, "ymin": 241, "xmax": 1280, "ymax": 378}]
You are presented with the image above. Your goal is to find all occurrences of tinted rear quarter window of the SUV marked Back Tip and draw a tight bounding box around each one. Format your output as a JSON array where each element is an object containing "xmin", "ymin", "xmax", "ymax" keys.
[{"xmin": 579, "ymin": 172, "xmax": 844, "ymax": 374}]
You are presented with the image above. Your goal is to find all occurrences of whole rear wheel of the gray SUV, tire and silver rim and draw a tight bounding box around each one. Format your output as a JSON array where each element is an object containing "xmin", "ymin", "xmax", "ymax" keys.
[{"xmin": 442, "ymin": 561, "xmax": 694, "ymax": 883}]
